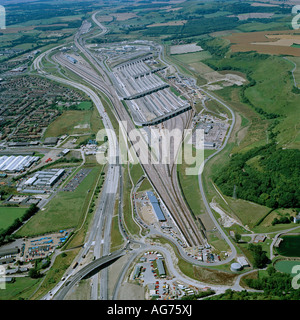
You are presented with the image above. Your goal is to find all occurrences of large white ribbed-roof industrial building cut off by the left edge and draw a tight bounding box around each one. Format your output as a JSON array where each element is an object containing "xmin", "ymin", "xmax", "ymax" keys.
[{"xmin": 0, "ymin": 156, "xmax": 39, "ymax": 173}]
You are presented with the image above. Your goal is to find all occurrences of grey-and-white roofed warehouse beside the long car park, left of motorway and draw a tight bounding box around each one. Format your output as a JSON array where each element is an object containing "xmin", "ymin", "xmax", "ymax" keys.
[{"xmin": 24, "ymin": 169, "xmax": 65, "ymax": 187}]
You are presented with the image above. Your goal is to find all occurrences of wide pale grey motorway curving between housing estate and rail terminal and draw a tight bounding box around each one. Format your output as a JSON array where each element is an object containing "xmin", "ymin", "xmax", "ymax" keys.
[{"xmin": 33, "ymin": 41, "xmax": 120, "ymax": 299}]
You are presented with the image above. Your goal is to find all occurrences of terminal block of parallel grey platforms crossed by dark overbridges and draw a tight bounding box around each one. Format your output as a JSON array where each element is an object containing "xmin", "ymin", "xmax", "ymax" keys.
[{"xmin": 113, "ymin": 57, "xmax": 192, "ymax": 126}]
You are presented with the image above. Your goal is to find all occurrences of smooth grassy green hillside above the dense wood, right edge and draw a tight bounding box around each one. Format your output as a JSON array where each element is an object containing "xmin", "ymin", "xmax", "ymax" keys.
[{"xmin": 205, "ymin": 53, "xmax": 300, "ymax": 148}]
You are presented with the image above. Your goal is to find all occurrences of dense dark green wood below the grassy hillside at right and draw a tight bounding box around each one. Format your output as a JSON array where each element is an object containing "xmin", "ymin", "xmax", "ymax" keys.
[{"xmin": 214, "ymin": 141, "xmax": 300, "ymax": 208}]
